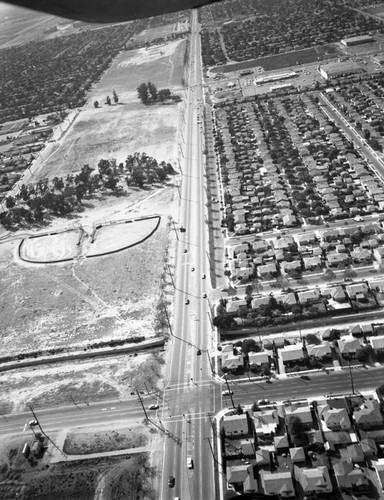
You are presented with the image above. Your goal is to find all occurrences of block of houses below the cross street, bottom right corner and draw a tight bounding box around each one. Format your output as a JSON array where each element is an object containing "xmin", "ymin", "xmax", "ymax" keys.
[{"xmin": 222, "ymin": 396, "xmax": 384, "ymax": 498}]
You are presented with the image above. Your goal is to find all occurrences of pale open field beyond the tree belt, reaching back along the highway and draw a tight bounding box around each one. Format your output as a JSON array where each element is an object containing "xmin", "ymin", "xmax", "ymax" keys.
[{"xmin": 36, "ymin": 40, "xmax": 186, "ymax": 179}]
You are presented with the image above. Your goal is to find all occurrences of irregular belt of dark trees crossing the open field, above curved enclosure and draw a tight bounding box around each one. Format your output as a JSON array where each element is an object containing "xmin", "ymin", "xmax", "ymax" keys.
[{"xmin": 0, "ymin": 152, "xmax": 175, "ymax": 229}]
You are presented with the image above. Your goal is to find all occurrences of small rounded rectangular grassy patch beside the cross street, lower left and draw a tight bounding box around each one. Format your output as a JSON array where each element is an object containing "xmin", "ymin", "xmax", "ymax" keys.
[{"xmin": 63, "ymin": 429, "xmax": 148, "ymax": 455}]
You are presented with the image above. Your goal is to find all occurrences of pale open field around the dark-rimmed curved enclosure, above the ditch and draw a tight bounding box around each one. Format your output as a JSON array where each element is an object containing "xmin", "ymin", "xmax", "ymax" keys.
[{"xmin": 0, "ymin": 188, "xmax": 176, "ymax": 356}]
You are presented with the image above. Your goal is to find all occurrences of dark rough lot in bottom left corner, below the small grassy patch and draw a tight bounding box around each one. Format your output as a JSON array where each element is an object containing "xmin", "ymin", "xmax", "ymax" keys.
[{"xmin": 0, "ymin": 437, "xmax": 156, "ymax": 500}]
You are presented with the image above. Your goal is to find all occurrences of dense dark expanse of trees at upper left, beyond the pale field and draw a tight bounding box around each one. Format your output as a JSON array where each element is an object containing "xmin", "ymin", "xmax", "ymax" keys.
[{"xmin": 0, "ymin": 20, "xmax": 146, "ymax": 123}]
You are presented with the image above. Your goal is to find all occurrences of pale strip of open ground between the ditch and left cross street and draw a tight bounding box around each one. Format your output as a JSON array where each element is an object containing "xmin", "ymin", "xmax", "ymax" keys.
[{"xmin": 0, "ymin": 353, "xmax": 163, "ymax": 414}]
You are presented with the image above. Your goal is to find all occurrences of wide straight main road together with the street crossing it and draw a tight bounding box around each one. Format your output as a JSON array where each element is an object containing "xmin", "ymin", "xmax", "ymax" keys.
[{"xmin": 0, "ymin": 11, "xmax": 383, "ymax": 500}]
